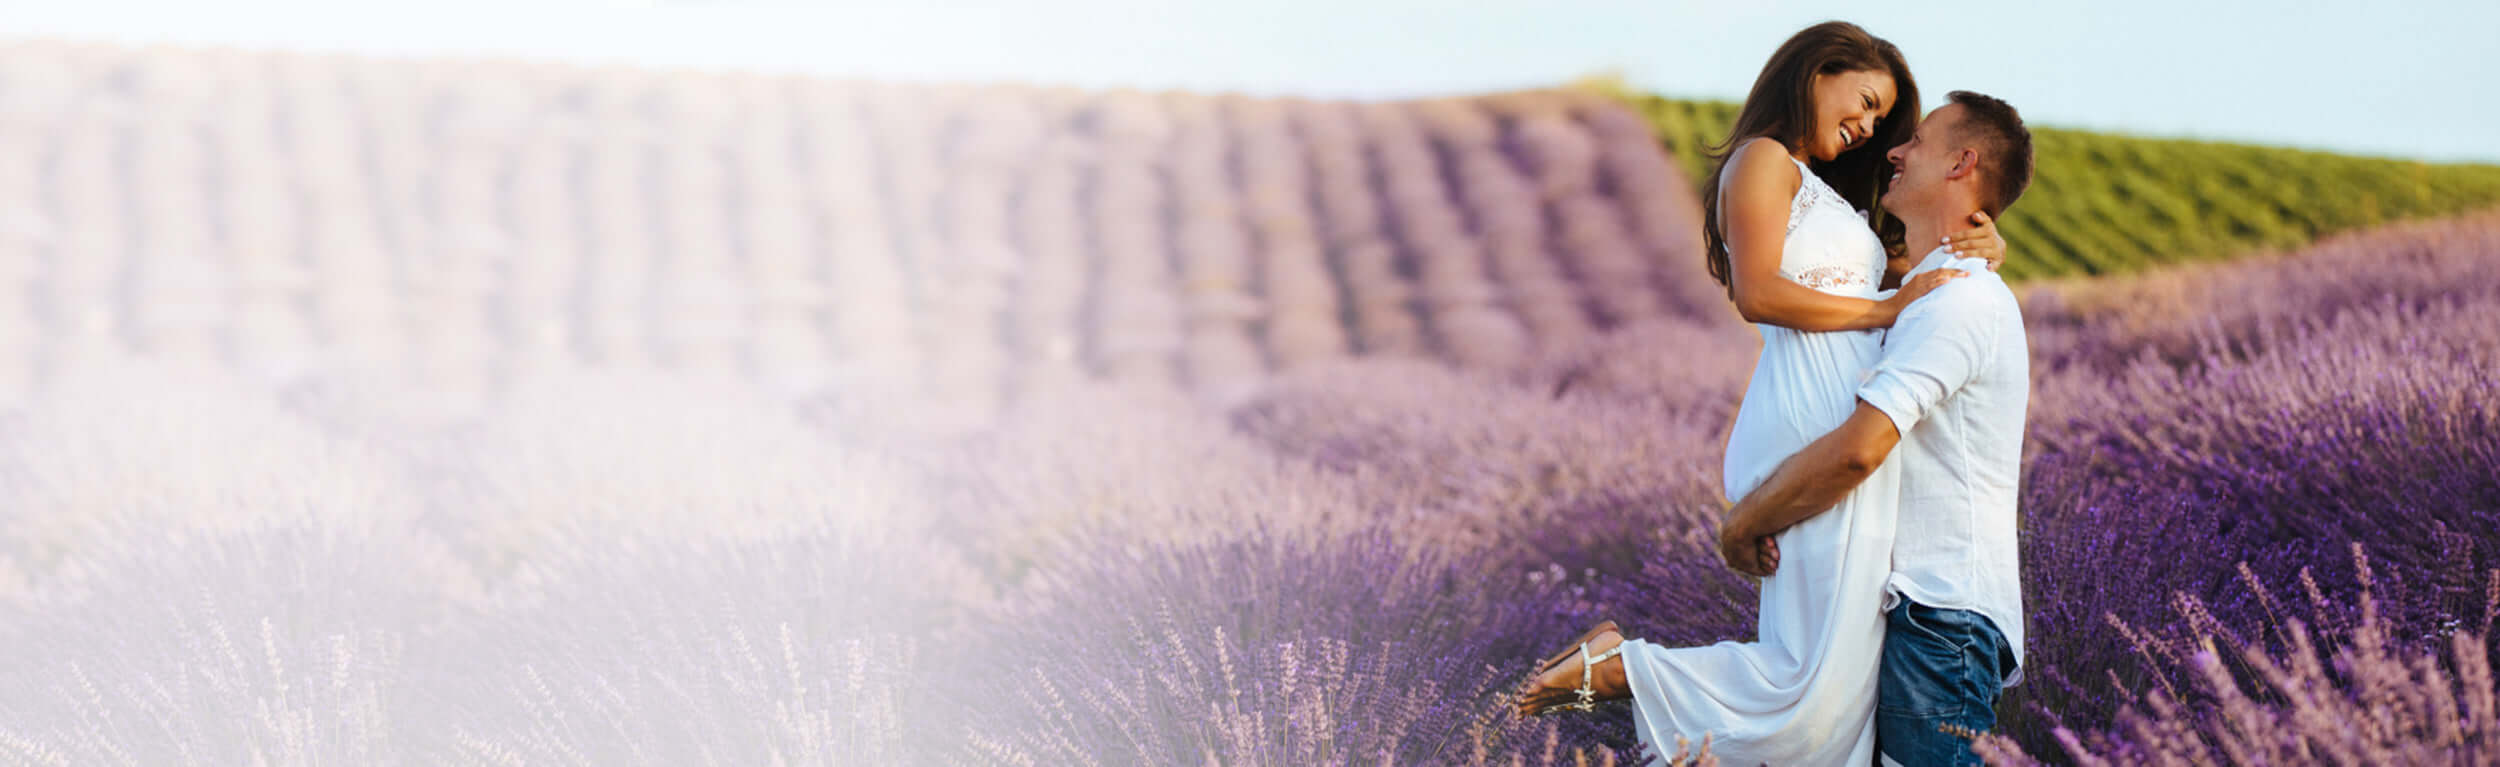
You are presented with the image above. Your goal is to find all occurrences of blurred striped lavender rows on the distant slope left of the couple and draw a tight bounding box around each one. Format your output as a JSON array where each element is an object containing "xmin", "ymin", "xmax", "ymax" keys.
[{"xmin": 0, "ymin": 42, "xmax": 1725, "ymax": 427}]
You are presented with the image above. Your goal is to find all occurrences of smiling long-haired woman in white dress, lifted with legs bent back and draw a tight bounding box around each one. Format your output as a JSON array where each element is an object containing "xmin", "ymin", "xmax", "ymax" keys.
[{"xmin": 1518, "ymin": 22, "xmax": 2003, "ymax": 765}]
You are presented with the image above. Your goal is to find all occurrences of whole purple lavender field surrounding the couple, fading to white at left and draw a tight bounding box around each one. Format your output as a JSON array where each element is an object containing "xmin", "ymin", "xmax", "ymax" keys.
[{"xmin": 0, "ymin": 42, "xmax": 2500, "ymax": 765}]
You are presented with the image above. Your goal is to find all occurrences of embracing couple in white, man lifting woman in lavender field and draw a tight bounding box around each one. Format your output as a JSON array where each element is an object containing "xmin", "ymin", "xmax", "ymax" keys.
[{"xmin": 1518, "ymin": 22, "xmax": 2033, "ymax": 765}]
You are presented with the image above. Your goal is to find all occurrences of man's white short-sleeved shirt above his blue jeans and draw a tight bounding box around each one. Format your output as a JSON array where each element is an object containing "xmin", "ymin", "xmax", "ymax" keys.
[{"xmin": 1858, "ymin": 247, "xmax": 2030, "ymax": 687}]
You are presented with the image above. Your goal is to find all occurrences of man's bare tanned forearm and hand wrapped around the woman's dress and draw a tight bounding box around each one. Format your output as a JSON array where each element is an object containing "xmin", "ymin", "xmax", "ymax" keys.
[{"xmin": 1728, "ymin": 402, "xmax": 1900, "ymax": 537}]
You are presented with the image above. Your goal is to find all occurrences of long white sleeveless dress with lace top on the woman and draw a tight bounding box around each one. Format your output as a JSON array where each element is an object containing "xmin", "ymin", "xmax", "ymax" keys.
[{"xmin": 1623, "ymin": 162, "xmax": 1900, "ymax": 767}]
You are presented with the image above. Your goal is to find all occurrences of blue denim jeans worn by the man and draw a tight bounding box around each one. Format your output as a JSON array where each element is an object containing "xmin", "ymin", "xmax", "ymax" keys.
[{"xmin": 1875, "ymin": 600, "xmax": 2015, "ymax": 767}]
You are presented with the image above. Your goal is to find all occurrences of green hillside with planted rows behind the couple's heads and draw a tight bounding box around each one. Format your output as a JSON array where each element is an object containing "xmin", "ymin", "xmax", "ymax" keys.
[{"xmin": 1585, "ymin": 82, "xmax": 2500, "ymax": 277}]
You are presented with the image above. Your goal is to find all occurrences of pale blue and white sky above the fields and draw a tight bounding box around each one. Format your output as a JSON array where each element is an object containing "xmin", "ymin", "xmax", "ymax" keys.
[{"xmin": 19, "ymin": 0, "xmax": 2500, "ymax": 162}]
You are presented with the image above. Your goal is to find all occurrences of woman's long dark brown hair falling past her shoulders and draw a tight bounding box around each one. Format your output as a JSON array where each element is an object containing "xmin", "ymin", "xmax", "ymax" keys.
[{"xmin": 1703, "ymin": 22, "xmax": 1920, "ymax": 300}]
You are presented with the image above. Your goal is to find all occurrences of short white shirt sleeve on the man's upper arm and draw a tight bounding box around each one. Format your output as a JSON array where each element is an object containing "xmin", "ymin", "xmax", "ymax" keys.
[{"xmin": 1858, "ymin": 285, "xmax": 2000, "ymax": 437}]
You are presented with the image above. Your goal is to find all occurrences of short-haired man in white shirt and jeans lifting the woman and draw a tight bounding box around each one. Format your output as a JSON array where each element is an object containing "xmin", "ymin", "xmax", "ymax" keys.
[{"xmin": 1720, "ymin": 90, "xmax": 2033, "ymax": 765}]
